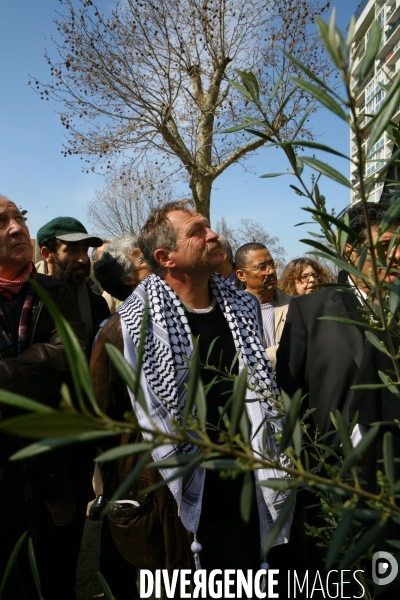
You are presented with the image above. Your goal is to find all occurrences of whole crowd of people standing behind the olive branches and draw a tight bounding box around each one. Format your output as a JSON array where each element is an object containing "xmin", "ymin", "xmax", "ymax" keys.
[{"xmin": 0, "ymin": 196, "xmax": 400, "ymax": 600}]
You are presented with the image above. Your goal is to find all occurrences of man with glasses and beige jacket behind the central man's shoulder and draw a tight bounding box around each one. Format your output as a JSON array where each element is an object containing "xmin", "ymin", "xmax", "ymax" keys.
[{"xmin": 235, "ymin": 242, "xmax": 290, "ymax": 368}]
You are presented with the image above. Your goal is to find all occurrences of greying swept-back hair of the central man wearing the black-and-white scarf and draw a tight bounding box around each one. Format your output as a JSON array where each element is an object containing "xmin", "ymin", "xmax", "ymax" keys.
[{"xmin": 138, "ymin": 200, "xmax": 193, "ymax": 275}]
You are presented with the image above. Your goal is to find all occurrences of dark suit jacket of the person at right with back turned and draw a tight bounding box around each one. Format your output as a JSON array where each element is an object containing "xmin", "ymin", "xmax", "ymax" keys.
[{"xmin": 276, "ymin": 274, "xmax": 365, "ymax": 435}]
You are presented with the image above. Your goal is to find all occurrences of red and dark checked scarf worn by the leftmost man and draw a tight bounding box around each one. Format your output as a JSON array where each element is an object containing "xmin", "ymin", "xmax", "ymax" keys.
[{"xmin": 0, "ymin": 263, "xmax": 36, "ymax": 360}]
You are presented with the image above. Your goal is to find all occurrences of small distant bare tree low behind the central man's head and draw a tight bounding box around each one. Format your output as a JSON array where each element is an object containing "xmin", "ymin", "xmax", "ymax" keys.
[{"xmin": 88, "ymin": 164, "xmax": 174, "ymax": 237}]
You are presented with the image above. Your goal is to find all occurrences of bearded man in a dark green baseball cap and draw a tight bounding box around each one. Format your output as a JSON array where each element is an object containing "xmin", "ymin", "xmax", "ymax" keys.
[{"xmin": 37, "ymin": 217, "xmax": 110, "ymax": 356}]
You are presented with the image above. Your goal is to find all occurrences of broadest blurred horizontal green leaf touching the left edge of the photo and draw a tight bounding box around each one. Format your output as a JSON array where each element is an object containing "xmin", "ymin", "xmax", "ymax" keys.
[{"xmin": 0, "ymin": 411, "xmax": 103, "ymax": 438}]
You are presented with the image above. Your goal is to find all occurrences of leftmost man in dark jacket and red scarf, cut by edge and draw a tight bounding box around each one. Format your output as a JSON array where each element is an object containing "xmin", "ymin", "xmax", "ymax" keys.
[{"xmin": 0, "ymin": 196, "xmax": 93, "ymax": 600}]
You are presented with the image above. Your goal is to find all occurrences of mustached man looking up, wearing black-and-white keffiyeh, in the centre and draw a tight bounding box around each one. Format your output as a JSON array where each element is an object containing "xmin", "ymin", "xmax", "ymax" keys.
[{"xmin": 91, "ymin": 201, "xmax": 291, "ymax": 584}]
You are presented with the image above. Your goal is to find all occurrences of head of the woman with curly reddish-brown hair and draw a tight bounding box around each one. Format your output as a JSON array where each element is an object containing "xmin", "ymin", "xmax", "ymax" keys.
[{"xmin": 279, "ymin": 256, "xmax": 330, "ymax": 296}]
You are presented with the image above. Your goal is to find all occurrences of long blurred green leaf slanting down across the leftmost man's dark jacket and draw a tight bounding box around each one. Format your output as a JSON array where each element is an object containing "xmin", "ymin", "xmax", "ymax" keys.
[{"xmin": 29, "ymin": 280, "xmax": 101, "ymax": 416}]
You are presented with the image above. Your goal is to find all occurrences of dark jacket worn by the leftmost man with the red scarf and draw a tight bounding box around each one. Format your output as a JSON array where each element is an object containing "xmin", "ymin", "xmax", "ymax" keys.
[{"xmin": 0, "ymin": 274, "xmax": 93, "ymax": 563}]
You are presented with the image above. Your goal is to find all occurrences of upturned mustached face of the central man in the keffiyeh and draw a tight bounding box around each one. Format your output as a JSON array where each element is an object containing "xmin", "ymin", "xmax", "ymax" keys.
[{"xmin": 164, "ymin": 210, "xmax": 224, "ymax": 274}]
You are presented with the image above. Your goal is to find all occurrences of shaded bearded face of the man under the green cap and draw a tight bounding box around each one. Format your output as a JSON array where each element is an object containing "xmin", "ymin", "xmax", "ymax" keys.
[{"xmin": 42, "ymin": 240, "xmax": 90, "ymax": 285}]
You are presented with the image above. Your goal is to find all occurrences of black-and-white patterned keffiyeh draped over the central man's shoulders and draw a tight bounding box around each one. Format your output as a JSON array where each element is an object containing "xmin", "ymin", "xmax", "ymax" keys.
[{"xmin": 117, "ymin": 274, "xmax": 292, "ymax": 545}]
